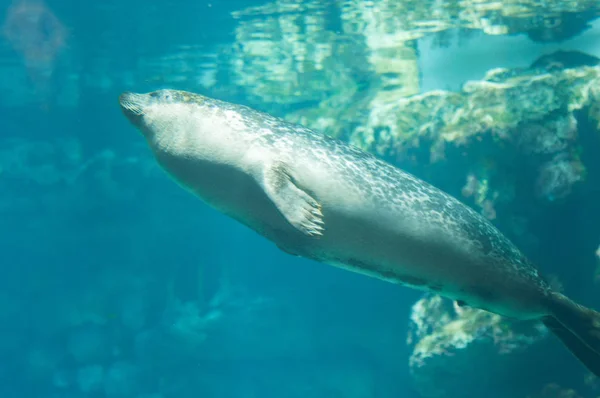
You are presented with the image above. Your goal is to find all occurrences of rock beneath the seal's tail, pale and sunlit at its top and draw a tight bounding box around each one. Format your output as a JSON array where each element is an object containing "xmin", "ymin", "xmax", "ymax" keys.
[{"xmin": 408, "ymin": 296, "xmax": 583, "ymax": 398}]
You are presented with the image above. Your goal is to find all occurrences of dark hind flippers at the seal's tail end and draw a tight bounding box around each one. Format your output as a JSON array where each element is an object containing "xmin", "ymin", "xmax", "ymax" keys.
[{"xmin": 543, "ymin": 293, "xmax": 600, "ymax": 377}]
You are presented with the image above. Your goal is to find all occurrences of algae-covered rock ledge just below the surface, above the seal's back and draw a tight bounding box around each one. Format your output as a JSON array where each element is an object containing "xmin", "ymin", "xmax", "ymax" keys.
[{"xmin": 351, "ymin": 62, "xmax": 600, "ymax": 158}]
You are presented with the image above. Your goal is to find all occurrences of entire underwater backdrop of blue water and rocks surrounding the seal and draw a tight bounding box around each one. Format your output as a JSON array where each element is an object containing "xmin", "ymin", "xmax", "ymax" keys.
[{"xmin": 0, "ymin": 0, "xmax": 600, "ymax": 398}]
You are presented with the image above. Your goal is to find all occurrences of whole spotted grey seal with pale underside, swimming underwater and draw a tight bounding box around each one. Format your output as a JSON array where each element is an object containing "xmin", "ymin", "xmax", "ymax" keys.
[{"xmin": 120, "ymin": 90, "xmax": 600, "ymax": 376}]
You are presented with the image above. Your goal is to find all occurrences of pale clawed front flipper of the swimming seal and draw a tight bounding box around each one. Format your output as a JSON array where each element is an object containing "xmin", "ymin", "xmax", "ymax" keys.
[{"xmin": 262, "ymin": 162, "xmax": 324, "ymax": 237}]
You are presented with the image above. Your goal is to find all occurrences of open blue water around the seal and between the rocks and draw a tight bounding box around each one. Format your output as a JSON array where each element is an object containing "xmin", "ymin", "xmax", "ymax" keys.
[{"xmin": 0, "ymin": 0, "xmax": 600, "ymax": 398}]
